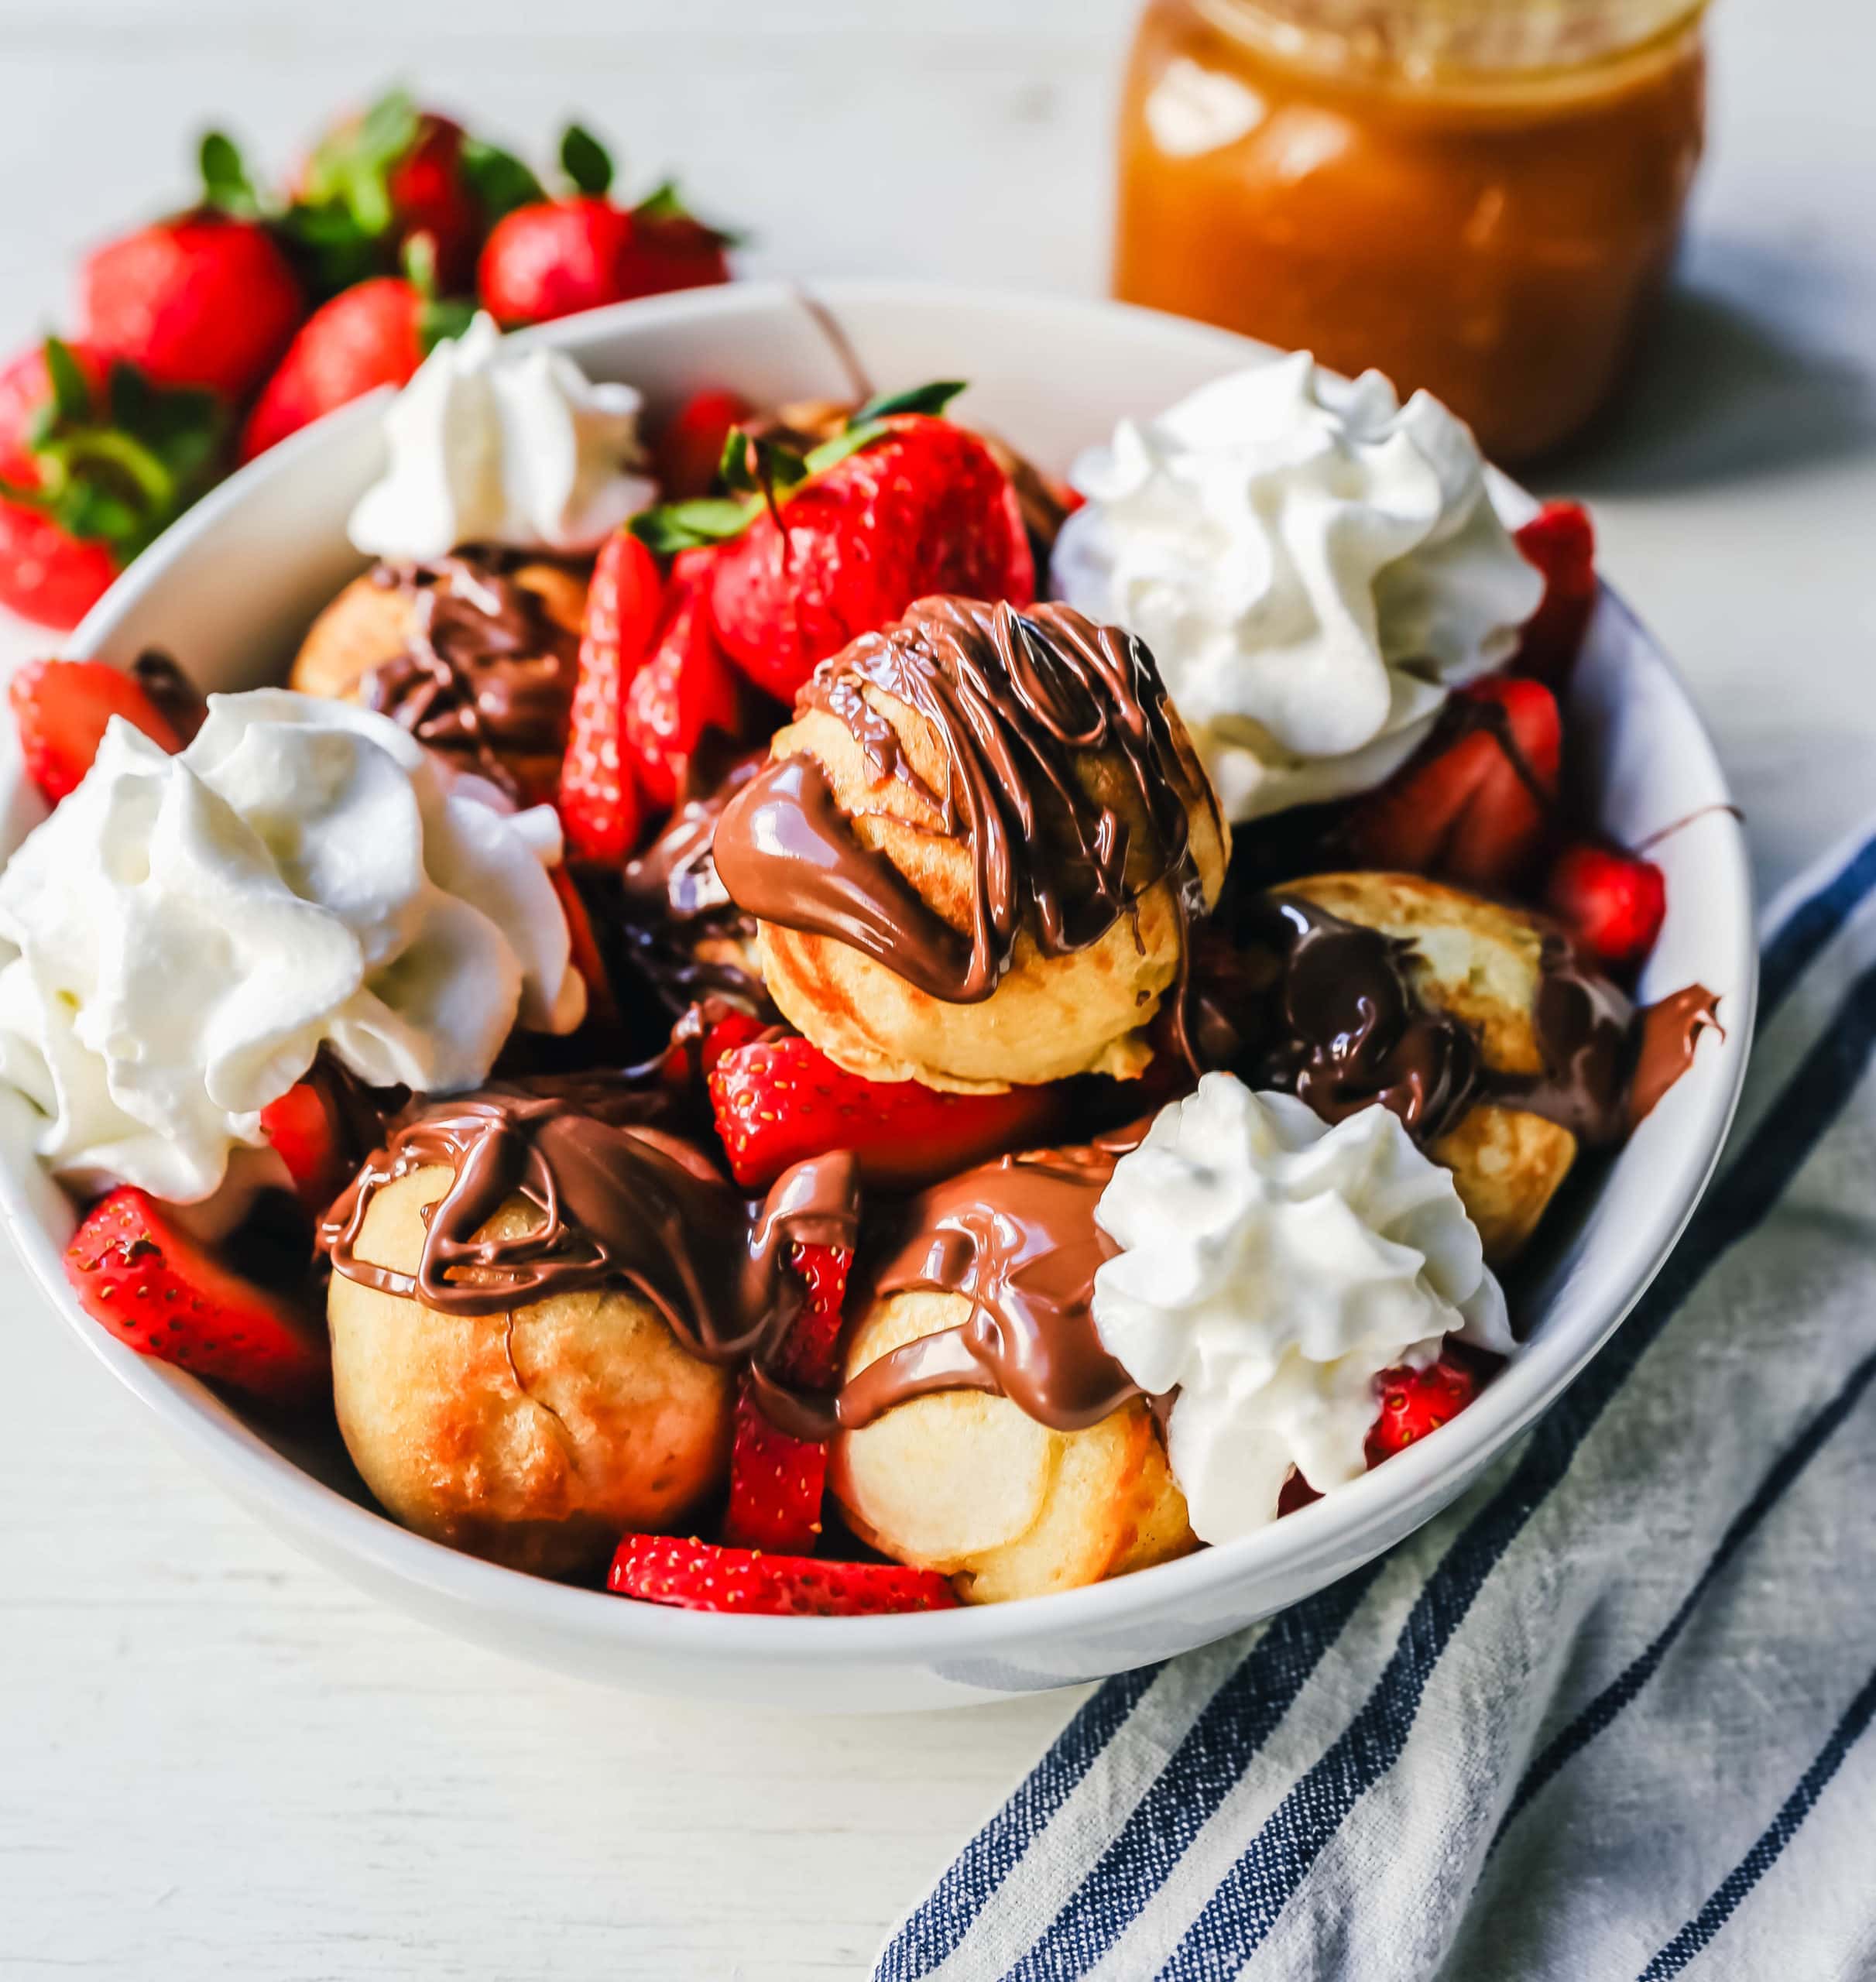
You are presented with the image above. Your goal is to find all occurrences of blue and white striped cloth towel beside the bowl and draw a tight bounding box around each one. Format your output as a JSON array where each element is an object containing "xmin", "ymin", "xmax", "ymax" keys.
[{"xmin": 875, "ymin": 820, "xmax": 1876, "ymax": 1982}]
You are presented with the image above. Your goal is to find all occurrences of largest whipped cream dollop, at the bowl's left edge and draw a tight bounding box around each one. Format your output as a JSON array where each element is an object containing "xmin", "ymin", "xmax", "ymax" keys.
[{"xmin": 0, "ymin": 688, "xmax": 585, "ymax": 1203}]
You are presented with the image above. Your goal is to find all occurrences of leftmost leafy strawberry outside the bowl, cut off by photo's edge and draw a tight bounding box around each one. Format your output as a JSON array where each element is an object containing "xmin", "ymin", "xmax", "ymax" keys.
[{"xmin": 0, "ymin": 337, "xmax": 224, "ymax": 629}]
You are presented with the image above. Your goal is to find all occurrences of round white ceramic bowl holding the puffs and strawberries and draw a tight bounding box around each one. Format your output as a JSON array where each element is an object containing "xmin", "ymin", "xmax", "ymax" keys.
[{"xmin": 0, "ymin": 283, "xmax": 1755, "ymax": 1710}]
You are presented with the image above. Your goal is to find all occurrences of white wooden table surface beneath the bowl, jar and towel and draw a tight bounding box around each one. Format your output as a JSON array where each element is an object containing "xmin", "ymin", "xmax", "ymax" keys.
[{"xmin": 0, "ymin": 0, "xmax": 1876, "ymax": 1982}]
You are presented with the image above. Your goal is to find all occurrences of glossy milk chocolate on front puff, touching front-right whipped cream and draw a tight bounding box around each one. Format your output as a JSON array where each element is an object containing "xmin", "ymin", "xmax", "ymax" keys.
[{"xmin": 833, "ymin": 1122, "xmax": 1146, "ymax": 1431}]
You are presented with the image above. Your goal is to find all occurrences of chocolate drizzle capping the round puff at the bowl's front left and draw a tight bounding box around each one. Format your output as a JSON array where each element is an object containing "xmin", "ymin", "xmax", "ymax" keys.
[{"xmin": 319, "ymin": 1075, "xmax": 859, "ymax": 1418}]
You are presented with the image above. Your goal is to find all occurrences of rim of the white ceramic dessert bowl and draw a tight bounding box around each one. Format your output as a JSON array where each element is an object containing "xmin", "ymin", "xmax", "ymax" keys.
[{"xmin": 0, "ymin": 277, "xmax": 1759, "ymax": 1667}]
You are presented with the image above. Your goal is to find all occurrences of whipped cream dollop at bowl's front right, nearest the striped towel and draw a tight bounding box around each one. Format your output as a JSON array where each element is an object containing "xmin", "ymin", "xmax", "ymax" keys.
[{"xmin": 1095, "ymin": 1075, "xmax": 1513, "ymax": 1542}]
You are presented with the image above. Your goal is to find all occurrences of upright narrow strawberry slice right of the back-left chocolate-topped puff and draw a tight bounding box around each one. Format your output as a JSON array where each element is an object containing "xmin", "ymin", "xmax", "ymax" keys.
[{"xmin": 557, "ymin": 530, "xmax": 664, "ymax": 866}]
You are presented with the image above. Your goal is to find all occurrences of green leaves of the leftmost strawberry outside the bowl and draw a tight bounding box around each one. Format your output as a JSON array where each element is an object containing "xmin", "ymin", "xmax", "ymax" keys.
[{"xmin": 0, "ymin": 337, "xmax": 228, "ymax": 563}]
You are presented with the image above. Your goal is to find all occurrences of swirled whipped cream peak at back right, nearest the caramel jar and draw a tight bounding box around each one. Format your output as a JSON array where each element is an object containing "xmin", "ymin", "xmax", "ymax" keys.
[{"xmin": 1053, "ymin": 351, "xmax": 1543, "ymax": 821}]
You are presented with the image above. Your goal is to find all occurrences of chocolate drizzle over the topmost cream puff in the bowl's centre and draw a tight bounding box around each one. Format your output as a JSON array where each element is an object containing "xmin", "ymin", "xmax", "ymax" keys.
[{"xmin": 716, "ymin": 598, "xmax": 1218, "ymax": 1030}]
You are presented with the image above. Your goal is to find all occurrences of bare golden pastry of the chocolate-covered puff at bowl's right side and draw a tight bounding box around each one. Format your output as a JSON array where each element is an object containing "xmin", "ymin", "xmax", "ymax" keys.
[{"xmin": 1283, "ymin": 874, "xmax": 1576, "ymax": 1267}]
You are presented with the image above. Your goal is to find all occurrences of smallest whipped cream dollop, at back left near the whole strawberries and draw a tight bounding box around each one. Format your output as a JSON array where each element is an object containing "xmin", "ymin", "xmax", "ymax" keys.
[{"xmin": 349, "ymin": 315, "xmax": 658, "ymax": 559}]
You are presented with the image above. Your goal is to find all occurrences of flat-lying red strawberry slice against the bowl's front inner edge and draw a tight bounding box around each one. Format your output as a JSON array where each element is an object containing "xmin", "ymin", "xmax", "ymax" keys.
[{"xmin": 607, "ymin": 1534, "xmax": 958, "ymax": 1617}]
